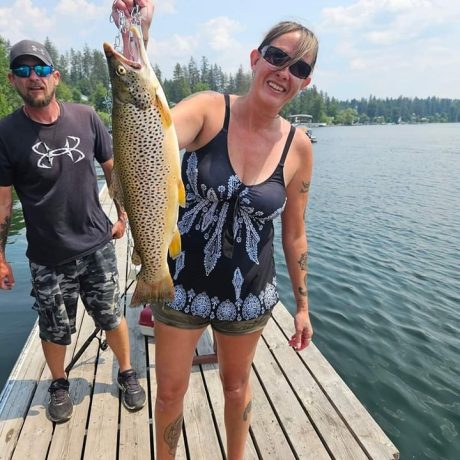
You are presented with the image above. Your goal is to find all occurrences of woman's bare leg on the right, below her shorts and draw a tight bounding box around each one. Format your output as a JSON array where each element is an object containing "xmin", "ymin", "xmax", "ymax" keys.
[{"xmin": 215, "ymin": 331, "xmax": 262, "ymax": 460}]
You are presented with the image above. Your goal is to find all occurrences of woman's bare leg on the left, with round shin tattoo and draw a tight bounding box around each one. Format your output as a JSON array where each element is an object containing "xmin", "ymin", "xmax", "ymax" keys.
[{"xmin": 155, "ymin": 320, "xmax": 204, "ymax": 460}]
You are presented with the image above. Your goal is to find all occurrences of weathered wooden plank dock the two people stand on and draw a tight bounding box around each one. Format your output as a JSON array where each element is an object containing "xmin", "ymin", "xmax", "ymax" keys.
[{"xmin": 0, "ymin": 190, "xmax": 399, "ymax": 460}]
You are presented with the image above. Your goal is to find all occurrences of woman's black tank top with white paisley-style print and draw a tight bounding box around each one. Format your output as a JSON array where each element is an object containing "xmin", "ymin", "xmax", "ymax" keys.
[{"xmin": 169, "ymin": 94, "xmax": 295, "ymax": 321}]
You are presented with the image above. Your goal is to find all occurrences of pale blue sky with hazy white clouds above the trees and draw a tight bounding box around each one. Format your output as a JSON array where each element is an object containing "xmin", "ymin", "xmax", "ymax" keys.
[{"xmin": 0, "ymin": 0, "xmax": 460, "ymax": 100}]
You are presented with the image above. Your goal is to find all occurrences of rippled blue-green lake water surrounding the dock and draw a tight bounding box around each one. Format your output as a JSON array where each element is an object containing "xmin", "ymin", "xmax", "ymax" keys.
[{"xmin": 0, "ymin": 124, "xmax": 460, "ymax": 460}]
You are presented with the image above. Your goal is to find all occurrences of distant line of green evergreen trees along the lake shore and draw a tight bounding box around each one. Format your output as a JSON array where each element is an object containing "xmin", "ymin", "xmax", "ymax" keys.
[{"xmin": 0, "ymin": 36, "xmax": 460, "ymax": 125}]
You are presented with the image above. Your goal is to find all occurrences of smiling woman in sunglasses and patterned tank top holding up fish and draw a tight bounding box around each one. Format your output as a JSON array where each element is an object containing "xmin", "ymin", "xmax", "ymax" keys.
[{"xmin": 114, "ymin": 0, "xmax": 318, "ymax": 460}]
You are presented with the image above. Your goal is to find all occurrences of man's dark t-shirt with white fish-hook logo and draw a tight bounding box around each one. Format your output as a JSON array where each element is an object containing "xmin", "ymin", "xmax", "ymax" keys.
[{"xmin": 0, "ymin": 103, "xmax": 112, "ymax": 266}]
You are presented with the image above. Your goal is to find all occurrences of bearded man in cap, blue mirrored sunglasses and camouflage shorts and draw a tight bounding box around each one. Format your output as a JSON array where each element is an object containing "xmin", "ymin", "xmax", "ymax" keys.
[{"xmin": 0, "ymin": 40, "xmax": 146, "ymax": 422}]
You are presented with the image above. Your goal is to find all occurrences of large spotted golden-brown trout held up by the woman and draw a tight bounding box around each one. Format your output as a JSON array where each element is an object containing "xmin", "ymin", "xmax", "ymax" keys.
[{"xmin": 103, "ymin": 26, "xmax": 185, "ymax": 306}]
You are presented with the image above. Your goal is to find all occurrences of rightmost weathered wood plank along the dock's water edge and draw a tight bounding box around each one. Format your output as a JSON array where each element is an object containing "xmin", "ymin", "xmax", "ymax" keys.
[{"xmin": 273, "ymin": 307, "xmax": 399, "ymax": 460}]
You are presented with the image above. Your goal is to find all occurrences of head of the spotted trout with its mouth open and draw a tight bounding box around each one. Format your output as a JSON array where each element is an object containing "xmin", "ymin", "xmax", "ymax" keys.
[{"xmin": 104, "ymin": 26, "xmax": 160, "ymax": 110}]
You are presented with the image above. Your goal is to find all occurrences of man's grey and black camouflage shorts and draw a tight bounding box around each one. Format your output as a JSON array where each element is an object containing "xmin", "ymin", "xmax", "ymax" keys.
[{"xmin": 30, "ymin": 242, "xmax": 122, "ymax": 345}]
